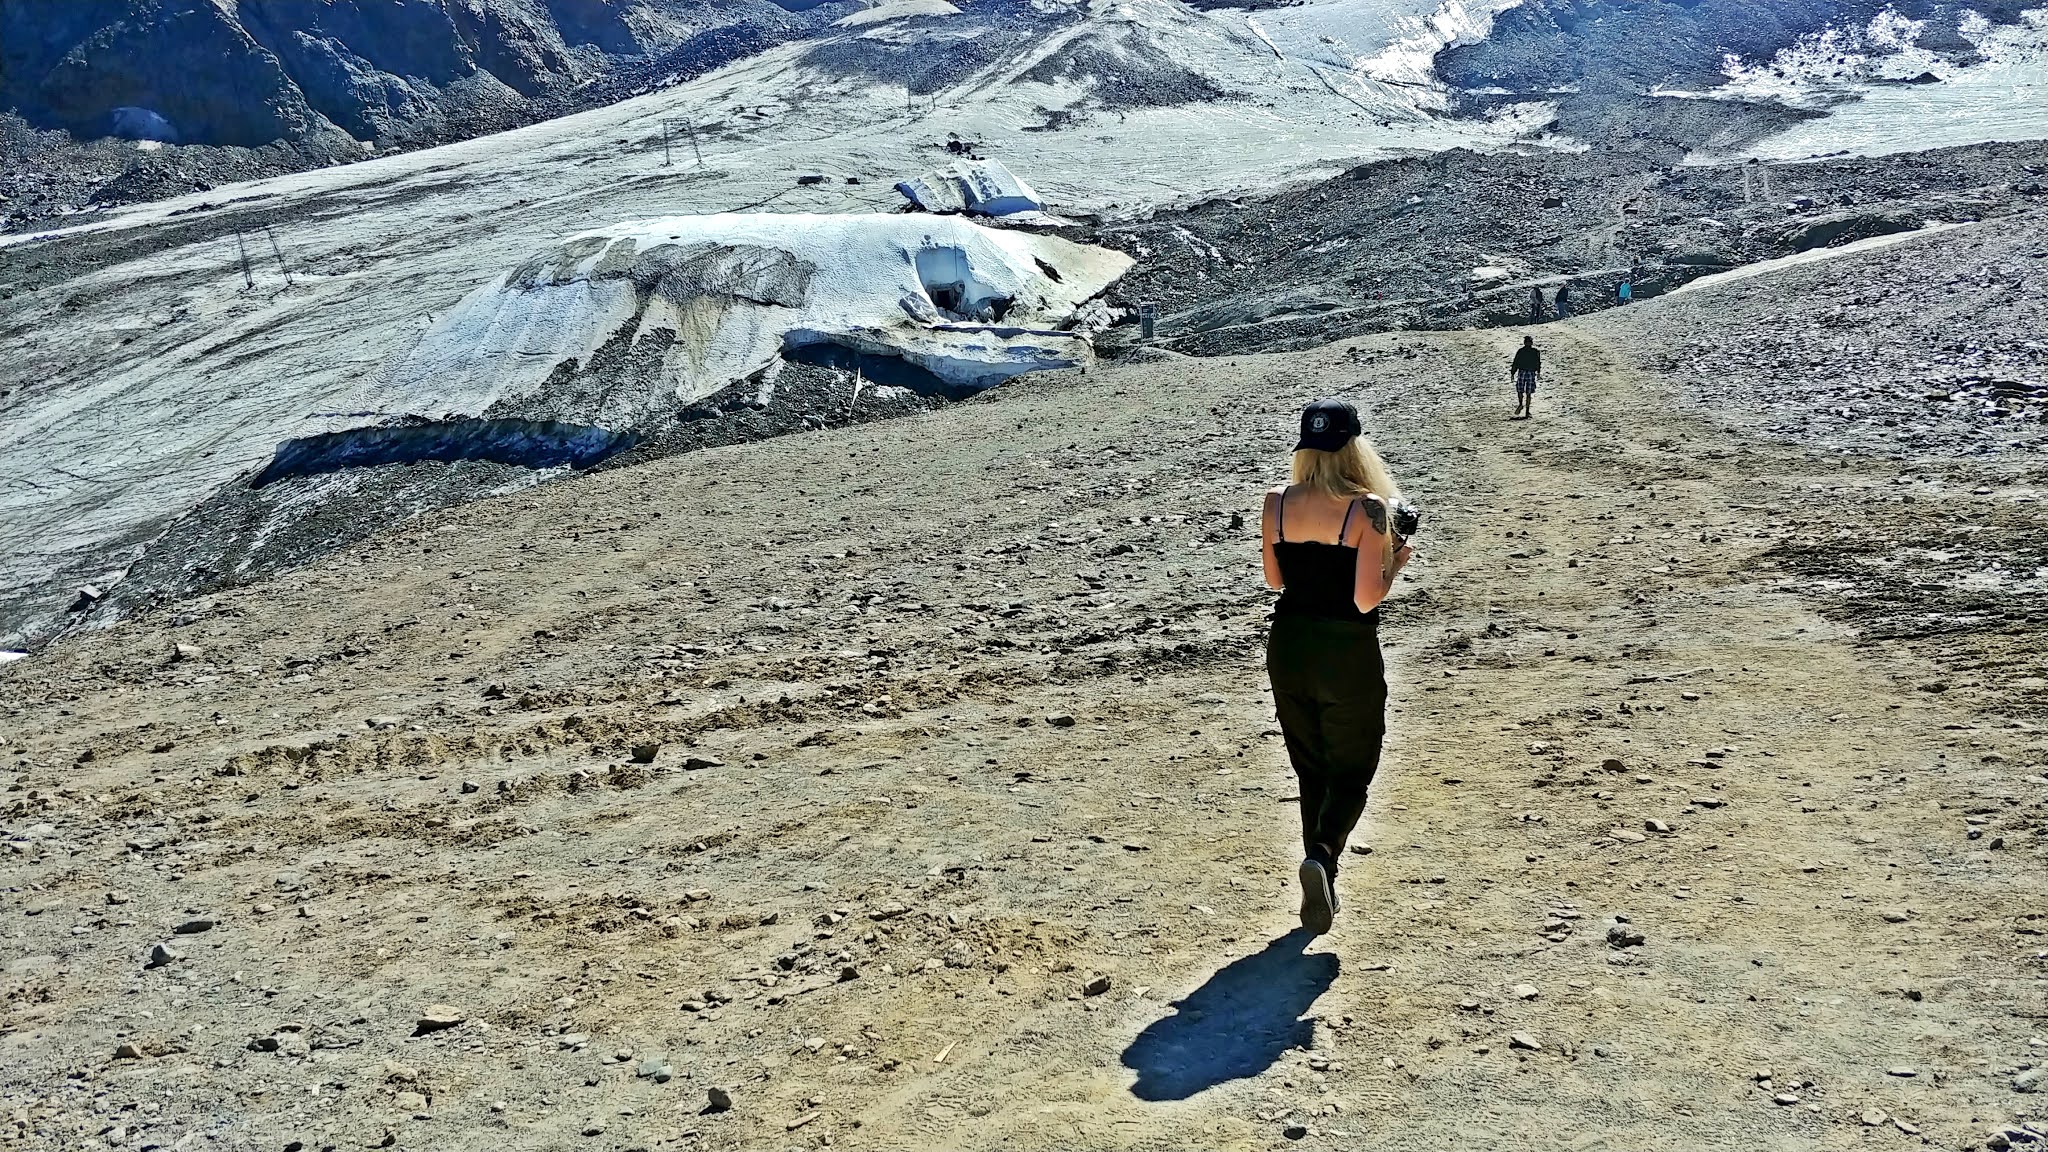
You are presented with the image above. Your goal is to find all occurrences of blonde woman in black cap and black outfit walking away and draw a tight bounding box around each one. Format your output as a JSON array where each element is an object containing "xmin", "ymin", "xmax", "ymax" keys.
[{"xmin": 1260, "ymin": 400, "xmax": 1413, "ymax": 935}]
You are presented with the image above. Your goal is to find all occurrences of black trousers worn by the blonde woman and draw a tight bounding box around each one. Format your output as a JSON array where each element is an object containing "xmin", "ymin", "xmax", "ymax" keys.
[{"xmin": 1266, "ymin": 617, "xmax": 1386, "ymax": 871}]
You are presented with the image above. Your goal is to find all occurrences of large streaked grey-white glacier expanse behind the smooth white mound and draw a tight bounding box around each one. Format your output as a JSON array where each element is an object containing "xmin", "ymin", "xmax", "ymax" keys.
[{"xmin": 0, "ymin": 0, "xmax": 1548, "ymax": 646}]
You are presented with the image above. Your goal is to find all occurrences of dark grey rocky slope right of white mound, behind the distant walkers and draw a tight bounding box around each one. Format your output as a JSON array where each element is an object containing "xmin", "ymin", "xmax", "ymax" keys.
[{"xmin": 1085, "ymin": 141, "xmax": 2048, "ymax": 355}]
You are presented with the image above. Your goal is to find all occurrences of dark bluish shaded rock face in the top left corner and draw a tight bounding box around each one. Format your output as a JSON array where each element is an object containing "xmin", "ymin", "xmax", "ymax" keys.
[{"xmin": 0, "ymin": 0, "xmax": 745, "ymax": 148}]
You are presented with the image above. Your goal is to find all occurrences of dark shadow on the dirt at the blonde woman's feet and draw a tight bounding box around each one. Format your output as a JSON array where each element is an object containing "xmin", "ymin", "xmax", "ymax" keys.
[{"xmin": 1124, "ymin": 929, "xmax": 1339, "ymax": 1101}]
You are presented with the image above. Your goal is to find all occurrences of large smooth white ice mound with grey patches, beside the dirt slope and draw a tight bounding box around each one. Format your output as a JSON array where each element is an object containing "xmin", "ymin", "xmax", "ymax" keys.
[{"xmin": 370, "ymin": 213, "xmax": 1130, "ymax": 426}]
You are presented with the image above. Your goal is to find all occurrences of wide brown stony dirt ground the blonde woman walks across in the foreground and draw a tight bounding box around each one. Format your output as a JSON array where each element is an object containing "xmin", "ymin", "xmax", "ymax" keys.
[{"xmin": 0, "ymin": 317, "xmax": 2048, "ymax": 1150}]
